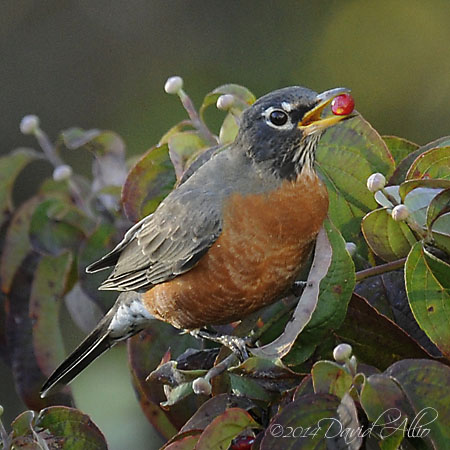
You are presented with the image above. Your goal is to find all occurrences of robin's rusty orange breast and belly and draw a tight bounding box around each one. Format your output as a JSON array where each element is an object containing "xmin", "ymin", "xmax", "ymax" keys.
[{"xmin": 144, "ymin": 176, "xmax": 328, "ymax": 329}]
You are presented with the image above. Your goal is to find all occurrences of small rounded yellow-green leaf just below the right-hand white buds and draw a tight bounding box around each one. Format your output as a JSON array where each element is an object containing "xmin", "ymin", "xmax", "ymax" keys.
[{"xmin": 361, "ymin": 209, "xmax": 416, "ymax": 261}]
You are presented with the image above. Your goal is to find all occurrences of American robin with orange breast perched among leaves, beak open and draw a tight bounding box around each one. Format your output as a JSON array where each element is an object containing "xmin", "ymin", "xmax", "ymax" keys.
[{"xmin": 41, "ymin": 86, "xmax": 350, "ymax": 396}]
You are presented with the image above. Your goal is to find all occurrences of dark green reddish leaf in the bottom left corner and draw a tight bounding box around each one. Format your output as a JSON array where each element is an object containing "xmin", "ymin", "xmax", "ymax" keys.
[{"xmin": 34, "ymin": 406, "xmax": 108, "ymax": 450}]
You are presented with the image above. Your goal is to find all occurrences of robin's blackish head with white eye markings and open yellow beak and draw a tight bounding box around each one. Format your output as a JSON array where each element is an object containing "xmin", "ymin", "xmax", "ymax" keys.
[{"xmin": 236, "ymin": 86, "xmax": 353, "ymax": 179}]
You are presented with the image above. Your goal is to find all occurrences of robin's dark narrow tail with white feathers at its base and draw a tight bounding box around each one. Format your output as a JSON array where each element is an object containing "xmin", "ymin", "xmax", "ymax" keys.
[{"xmin": 40, "ymin": 292, "xmax": 154, "ymax": 398}]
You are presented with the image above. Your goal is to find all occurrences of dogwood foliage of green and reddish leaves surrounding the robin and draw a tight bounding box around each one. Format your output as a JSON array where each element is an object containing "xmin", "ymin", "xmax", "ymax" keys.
[{"xmin": 0, "ymin": 77, "xmax": 450, "ymax": 449}]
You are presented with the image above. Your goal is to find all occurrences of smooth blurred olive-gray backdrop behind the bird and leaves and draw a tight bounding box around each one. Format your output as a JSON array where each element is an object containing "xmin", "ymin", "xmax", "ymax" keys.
[{"xmin": 0, "ymin": 0, "xmax": 450, "ymax": 450}]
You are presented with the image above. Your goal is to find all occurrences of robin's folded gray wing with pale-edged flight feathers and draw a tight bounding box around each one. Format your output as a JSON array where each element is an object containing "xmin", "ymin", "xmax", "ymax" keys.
[{"xmin": 94, "ymin": 190, "xmax": 222, "ymax": 291}]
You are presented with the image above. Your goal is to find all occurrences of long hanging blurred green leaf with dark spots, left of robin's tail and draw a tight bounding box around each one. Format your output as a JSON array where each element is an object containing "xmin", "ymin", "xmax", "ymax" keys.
[{"xmin": 30, "ymin": 252, "xmax": 73, "ymax": 375}]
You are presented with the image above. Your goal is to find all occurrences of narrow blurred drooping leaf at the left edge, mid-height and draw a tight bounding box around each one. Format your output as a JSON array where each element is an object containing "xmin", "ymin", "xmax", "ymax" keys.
[{"xmin": 0, "ymin": 197, "xmax": 39, "ymax": 293}]
